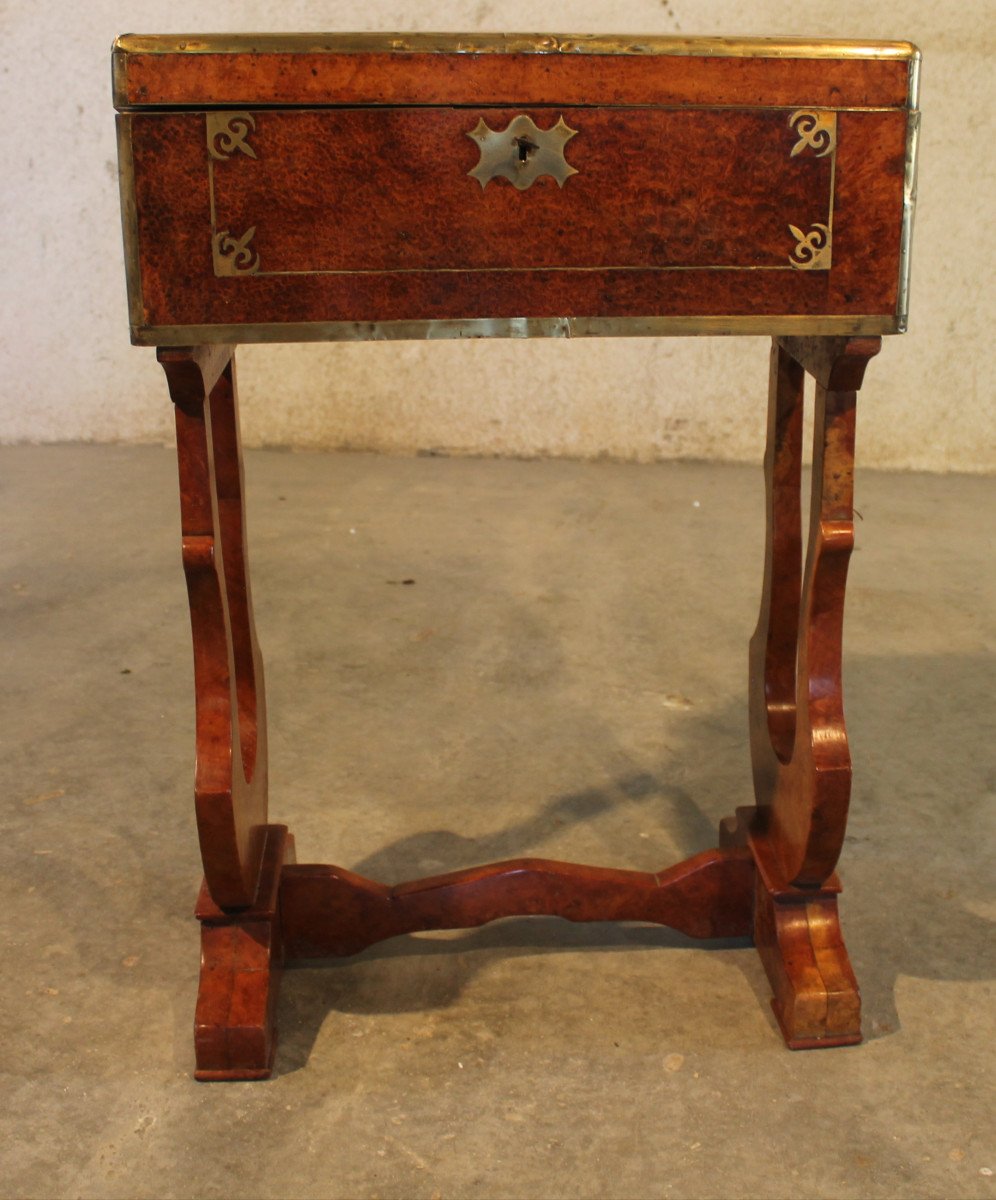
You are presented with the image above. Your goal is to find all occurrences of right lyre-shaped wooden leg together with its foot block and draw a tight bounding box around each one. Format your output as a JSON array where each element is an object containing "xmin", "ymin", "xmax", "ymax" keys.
[{"xmin": 740, "ymin": 337, "xmax": 881, "ymax": 1049}]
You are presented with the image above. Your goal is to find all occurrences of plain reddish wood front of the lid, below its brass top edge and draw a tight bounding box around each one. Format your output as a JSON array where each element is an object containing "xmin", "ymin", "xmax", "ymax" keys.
[{"xmin": 119, "ymin": 52, "xmax": 910, "ymax": 108}]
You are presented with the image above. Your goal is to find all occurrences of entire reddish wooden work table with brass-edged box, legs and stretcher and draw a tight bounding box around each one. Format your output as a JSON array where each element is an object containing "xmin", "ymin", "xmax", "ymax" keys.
[{"xmin": 114, "ymin": 34, "xmax": 919, "ymax": 1079}]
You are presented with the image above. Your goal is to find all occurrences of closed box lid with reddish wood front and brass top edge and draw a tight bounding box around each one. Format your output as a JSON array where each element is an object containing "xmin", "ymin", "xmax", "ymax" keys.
[{"xmin": 114, "ymin": 34, "xmax": 919, "ymax": 112}]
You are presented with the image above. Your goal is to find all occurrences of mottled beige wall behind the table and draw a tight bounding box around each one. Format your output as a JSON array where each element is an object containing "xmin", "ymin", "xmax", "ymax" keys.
[{"xmin": 0, "ymin": 0, "xmax": 996, "ymax": 472}]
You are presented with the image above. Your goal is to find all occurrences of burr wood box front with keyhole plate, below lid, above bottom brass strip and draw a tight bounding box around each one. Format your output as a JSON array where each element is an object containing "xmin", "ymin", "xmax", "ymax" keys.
[{"xmin": 120, "ymin": 97, "xmax": 906, "ymax": 341}]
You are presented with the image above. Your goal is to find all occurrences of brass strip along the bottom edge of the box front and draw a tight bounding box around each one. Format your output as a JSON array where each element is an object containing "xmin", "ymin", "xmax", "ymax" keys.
[{"xmin": 132, "ymin": 314, "xmax": 900, "ymax": 346}]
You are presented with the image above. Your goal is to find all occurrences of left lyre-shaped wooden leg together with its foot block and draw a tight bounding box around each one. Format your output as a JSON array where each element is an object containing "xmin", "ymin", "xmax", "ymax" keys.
[{"xmin": 158, "ymin": 346, "xmax": 290, "ymax": 1079}]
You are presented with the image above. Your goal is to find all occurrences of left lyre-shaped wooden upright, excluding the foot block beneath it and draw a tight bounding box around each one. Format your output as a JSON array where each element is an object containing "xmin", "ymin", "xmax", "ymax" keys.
[{"xmin": 158, "ymin": 346, "xmax": 266, "ymax": 908}]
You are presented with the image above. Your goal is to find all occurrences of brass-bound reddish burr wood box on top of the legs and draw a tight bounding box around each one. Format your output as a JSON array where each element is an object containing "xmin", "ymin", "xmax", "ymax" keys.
[{"xmin": 114, "ymin": 34, "xmax": 919, "ymax": 346}]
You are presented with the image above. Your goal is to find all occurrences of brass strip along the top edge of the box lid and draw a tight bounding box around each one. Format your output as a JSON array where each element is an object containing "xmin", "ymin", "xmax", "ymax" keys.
[{"xmin": 114, "ymin": 32, "xmax": 919, "ymax": 60}]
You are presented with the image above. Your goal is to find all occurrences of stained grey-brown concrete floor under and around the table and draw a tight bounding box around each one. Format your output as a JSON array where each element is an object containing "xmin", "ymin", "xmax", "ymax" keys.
[{"xmin": 0, "ymin": 446, "xmax": 996, "ymax": 1200}]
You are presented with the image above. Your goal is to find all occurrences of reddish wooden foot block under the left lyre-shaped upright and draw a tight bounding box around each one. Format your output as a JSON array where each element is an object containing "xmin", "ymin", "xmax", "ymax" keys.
[{"xmin": 193, "ymin": 826, "xmax": 293, "ymax": 1081}]
